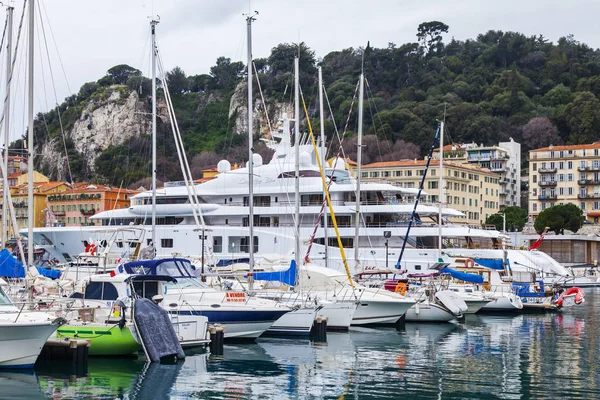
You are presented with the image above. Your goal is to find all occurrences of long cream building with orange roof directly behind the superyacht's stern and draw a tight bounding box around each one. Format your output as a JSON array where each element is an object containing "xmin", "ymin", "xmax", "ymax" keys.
[{"xmin": 361, "ymin": 159, "xmax": 500, "ymax": 226}]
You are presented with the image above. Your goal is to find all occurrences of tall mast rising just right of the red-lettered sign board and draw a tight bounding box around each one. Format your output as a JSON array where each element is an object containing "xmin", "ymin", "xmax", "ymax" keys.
[{"xmin": 246, "ymin": 15, "xmax": 254, "ymax": 292}]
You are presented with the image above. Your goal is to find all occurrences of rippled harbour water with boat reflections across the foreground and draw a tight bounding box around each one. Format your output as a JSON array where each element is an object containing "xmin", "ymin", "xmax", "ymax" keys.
[{"xmin": 0, "ymin": 289, "xmax": 600, "ymax": 399}]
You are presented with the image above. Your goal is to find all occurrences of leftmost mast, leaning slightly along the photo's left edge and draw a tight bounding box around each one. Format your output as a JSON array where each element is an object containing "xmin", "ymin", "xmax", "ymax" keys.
[{"xmin": 2, "ymin": 6, "xmax": 16, "ymax": 247}]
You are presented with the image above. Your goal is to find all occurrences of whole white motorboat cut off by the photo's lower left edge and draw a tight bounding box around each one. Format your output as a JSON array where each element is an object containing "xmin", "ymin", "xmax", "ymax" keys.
[{"xmin": 0, "ymin": 279, "xmax": 64, "ymax": 368}]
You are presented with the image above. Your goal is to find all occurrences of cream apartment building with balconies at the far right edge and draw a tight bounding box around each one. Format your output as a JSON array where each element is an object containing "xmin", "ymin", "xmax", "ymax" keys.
[{"xmin": 529, "ymin": 142, "xmax": 600, "ymax": 223}]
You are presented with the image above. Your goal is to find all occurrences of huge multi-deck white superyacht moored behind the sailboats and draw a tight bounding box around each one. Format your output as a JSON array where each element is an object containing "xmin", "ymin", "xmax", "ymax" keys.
[{"xmin": 21, "ymin": 116, "xmax": 566, "ymax": 275}]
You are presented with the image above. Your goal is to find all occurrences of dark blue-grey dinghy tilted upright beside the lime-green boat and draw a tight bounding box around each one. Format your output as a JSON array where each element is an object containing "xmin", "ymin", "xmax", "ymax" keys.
[{"xmin": 133, "ymin": 298, "xmax": 185, "ymax": 362}]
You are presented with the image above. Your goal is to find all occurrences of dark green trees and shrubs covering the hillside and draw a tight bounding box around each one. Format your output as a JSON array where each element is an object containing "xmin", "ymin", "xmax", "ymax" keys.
[{"xmin": 19, "ymin": 21, "xmax": 600, "ymax": 185}]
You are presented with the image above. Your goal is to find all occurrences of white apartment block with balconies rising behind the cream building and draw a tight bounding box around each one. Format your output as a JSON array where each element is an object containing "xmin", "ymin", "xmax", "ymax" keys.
[{"xmin": 434, "ymin": 138, "xmax": 521, "ymax": 208}]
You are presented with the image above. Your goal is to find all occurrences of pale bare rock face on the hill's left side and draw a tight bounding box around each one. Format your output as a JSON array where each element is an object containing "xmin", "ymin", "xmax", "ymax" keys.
[{"xmin": 69, "ymin": 86, "xmax": 152, "ymax": 170}]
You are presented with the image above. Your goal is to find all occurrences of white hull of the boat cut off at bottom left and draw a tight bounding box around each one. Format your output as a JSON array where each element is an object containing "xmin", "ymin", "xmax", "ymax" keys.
[{"xmin": 0, "ymin": 321, "xmax": 58, "ymax": 368}]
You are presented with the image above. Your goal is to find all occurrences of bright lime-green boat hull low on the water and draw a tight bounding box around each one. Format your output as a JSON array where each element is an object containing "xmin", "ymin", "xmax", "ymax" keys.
[{"xmin": 56, "ymin": 322, "xmax": 142, "ymax": 356}]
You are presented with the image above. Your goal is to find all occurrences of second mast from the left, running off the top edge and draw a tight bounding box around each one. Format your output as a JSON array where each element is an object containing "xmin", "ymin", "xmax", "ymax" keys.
[{"xmin": 26, "ymin": 0, "xmax": 35, "ymax": 268}]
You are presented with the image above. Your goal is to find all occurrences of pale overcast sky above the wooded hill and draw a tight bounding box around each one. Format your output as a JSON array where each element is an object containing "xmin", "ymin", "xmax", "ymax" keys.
[{"xmin": 0, "ymin": 0, "xmax": 600, "ymax": 142}]
